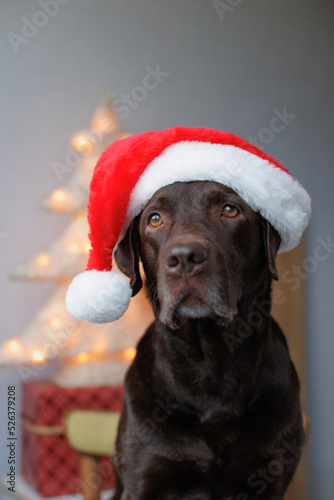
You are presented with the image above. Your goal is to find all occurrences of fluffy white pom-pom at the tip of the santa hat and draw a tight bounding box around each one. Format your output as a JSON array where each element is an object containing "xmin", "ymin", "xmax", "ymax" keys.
[{"xmin": 66, "ymin": 269, "xmax": 132, "ymax": 323}]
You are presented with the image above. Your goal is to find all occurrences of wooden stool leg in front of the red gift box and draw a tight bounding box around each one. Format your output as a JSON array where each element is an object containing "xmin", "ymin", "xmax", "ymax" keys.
[{"xmin": 80, "ymin": 455, "xmax": 101, "ymax": 500}]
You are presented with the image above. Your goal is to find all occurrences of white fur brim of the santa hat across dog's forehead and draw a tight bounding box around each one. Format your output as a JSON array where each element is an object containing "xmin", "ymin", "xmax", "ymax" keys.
[{"xmin": 119, "ymin": 141, "xmax": 311, "ymax": 252}]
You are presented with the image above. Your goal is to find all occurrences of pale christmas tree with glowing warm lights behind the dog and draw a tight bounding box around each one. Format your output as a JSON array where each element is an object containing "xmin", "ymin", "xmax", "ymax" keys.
[{"xmin": 0, "ymin": 97, "xmax": 152, "ymax": 386}]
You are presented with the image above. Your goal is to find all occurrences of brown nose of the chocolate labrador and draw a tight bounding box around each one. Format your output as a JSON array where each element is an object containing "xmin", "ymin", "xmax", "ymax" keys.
[{"xmin": 166, "ymin": 243, "xmax": 208, "ymax": 275}]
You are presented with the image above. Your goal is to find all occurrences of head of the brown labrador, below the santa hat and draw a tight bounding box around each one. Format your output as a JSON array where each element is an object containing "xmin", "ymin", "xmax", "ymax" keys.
[{"xmin": 115, "ymin": 181, "xmax": 280, "ymax": 328}]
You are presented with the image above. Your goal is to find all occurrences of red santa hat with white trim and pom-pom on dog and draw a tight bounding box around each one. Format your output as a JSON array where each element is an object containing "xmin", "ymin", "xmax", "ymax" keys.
[{"xmin": 66, "ymin": 127, "xmax": 311, "ymax": 323}]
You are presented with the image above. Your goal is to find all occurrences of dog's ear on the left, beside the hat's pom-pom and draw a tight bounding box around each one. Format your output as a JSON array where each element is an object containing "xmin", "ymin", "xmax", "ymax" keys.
[{"xmin": 114, "ymin": 217, "xmax": 143, "ymax": 297}]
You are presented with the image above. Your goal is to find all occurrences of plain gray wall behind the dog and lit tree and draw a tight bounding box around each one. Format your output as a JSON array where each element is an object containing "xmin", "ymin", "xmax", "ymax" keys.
[{"xmin": 0, "ymin": 0, "xmax": 334, "ymax": 500}]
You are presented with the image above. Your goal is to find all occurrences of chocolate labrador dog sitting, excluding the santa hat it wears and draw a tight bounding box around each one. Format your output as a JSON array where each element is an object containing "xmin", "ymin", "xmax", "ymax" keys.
[{"xmin": 114, "ymin": 181, "xmax": 304, "ymax": 500}]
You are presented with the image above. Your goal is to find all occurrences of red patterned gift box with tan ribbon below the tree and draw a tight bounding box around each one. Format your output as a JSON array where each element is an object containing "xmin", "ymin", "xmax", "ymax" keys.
[{"xmin": 21, "ymin": 381, "xmax": 123, "ymax": 497}]
